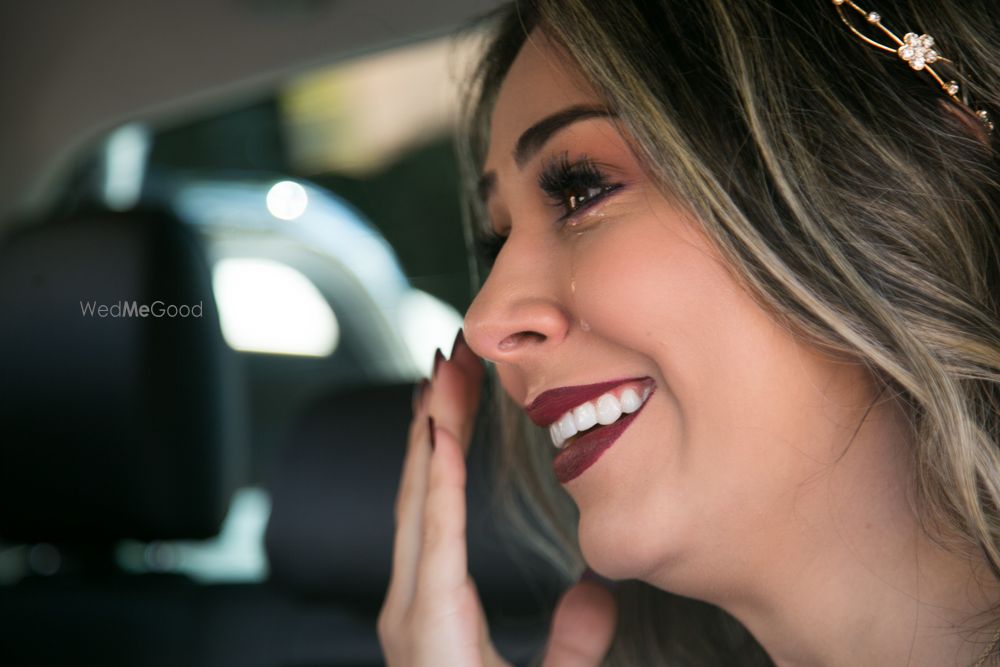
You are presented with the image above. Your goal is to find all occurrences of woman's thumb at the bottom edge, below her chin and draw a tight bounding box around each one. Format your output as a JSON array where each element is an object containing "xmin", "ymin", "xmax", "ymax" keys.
[{"xmin": 542, "ymin": 570, "xmax": 618, "ymax": 667}]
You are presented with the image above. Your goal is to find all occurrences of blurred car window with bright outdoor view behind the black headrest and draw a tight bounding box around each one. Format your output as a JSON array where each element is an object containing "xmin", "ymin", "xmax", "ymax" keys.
[{"xmin": 0, "ymin": 32, "xmax": 473, "ymax": 583}]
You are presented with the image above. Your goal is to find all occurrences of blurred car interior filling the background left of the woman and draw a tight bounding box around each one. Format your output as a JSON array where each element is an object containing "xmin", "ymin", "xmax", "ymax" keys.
[{"xmin": 0, "ymin": 0, "xmax": 560, "ymax": 667}]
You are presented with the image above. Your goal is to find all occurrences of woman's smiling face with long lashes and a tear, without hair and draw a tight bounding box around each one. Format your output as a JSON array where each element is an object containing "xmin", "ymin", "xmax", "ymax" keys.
[{"xmin": 465, "ymin": 31, "xmax": 892, "ymax": 593}]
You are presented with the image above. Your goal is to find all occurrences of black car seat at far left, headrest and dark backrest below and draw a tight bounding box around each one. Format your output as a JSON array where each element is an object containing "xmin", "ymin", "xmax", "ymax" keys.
[{"xmin": 0, "ymin": 212, "xmax": 241, "ymax": 667}]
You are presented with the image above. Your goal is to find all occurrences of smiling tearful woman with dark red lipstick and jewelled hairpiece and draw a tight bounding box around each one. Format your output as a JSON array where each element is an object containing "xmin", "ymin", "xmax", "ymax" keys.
[{"xmin": 379, "ymin": 0, "xmax": 1000, "ymax": 667}]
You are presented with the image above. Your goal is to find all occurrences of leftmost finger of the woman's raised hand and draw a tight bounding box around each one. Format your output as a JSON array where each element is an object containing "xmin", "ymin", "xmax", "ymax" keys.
[{"xmin": 386, "ymin": 405, "xmax": 431, "ymax": 611}]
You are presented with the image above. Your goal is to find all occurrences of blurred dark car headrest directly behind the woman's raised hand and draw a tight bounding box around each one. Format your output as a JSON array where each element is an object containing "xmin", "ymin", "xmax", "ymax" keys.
[{"xmin": 265, "ymin": 385, "xmax": 562, "ymax": 614}]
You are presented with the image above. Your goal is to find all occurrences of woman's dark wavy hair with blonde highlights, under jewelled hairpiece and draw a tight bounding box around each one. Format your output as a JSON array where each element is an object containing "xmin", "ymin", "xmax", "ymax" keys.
[{"xmin": 463, "ymin": 0, "xmax": 1000, "ymax": 666}]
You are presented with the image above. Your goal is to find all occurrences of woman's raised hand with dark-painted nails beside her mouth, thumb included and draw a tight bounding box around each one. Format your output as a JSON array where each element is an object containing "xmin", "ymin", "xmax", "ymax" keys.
[{"xmin": 378, "ymin": 332, "xmax": 617, "ymax": 667}]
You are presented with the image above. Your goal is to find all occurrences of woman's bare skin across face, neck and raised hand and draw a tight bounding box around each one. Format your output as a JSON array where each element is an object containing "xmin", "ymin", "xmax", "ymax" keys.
[{"xmin": 380, "ymin": 32, "xmax": 1000, "ymax": 666}]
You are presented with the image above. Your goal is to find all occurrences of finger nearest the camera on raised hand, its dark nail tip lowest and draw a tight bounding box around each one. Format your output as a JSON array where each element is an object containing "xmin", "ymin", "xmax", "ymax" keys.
[{"xmin": 416, "ymin": 417, "xmax": 468, "ymax": 601}]
